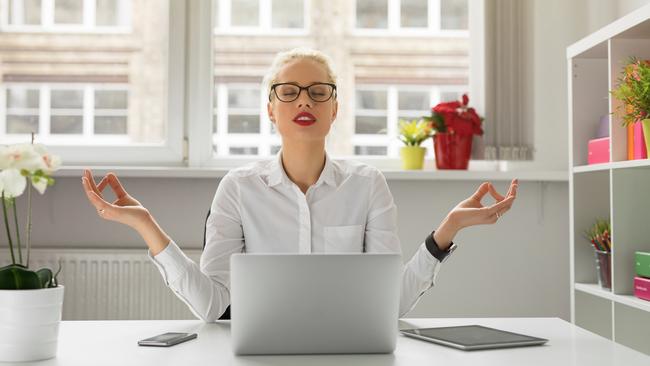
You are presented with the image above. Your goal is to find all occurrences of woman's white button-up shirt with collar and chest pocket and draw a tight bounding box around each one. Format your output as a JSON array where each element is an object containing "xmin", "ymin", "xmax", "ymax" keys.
[{"xmin": 149, "ymin": 153, "xmax": 440, "ymax": 322}]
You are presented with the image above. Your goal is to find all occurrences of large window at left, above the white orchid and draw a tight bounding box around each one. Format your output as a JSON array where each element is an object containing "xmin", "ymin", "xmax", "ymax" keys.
[{"xmin": 0, "ymin": 0, "xmax": 185, "ymax": 165}]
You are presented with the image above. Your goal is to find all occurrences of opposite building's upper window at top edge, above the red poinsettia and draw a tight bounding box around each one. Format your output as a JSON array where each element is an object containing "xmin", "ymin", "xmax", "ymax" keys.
[{"xmin": 355, "ymin": 0, "xmax": 469, "ymax": 36}]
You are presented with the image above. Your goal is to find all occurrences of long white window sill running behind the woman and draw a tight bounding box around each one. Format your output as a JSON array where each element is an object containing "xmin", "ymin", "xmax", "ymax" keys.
[{"xmin": 54, "ymin": 166, "xmax": 569, "ymax": 182}]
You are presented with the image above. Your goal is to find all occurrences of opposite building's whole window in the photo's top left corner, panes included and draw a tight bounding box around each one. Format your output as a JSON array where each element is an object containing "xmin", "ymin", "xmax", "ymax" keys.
[{"xmin": 0, "ymin": 0, "xmax": 132, "ymax": 33}]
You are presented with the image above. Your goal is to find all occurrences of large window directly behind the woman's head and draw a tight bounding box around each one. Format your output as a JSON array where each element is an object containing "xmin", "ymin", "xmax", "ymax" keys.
[{"xmin": 205, "ymin": 0, "xmax": 469, "ymax": 166}]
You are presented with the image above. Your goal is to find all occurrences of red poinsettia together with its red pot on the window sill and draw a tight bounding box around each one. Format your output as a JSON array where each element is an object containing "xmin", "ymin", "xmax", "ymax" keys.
[{"xmin": 424, "ymin": 94, "xmax": 483, "ymax": 169}]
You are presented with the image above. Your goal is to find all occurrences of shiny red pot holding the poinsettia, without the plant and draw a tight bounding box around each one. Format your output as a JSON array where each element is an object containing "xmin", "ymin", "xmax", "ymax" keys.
[{"xmin": 433, "ymin": 133, "xmax": 474, "ymax": 170}]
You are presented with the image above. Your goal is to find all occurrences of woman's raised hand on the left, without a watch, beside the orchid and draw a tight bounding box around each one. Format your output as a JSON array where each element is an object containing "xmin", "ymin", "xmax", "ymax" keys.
[{"xmin": 81, "ymin": 169, "xmax": 150, "ymax": 230}]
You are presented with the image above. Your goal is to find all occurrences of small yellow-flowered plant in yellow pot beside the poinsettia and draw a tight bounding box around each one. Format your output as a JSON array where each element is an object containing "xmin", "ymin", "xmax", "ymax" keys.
[{"xmin": 398, "ymin": 119, "xmax": 432, "ymax": 170}]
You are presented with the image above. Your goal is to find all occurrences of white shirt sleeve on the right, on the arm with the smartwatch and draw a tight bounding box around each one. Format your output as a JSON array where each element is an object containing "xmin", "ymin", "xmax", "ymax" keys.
[{"xmin": 364, "ymin": 171, "xmax": 440, "ymax": 317}]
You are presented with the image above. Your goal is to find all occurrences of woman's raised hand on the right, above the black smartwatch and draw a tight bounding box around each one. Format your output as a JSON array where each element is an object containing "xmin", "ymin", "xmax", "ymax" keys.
[{"xmin": 447, "ymin": 179, "xmax": 519, "ymax": 229}]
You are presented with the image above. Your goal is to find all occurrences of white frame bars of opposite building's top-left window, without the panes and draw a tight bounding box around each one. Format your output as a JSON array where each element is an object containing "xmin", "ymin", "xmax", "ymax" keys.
[{"xmin": 0, "ymin": 0, "xmax": 132, "ymax": 34}]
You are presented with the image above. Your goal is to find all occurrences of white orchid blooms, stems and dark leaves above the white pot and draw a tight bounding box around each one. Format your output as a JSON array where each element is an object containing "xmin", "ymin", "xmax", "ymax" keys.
[{"xmin": 0, "ymin": 134, "xmax": 61, "ymax": 290}]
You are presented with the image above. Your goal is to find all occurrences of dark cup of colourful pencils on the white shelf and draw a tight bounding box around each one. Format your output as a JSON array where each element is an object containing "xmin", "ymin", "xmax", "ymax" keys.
[{"xmin": 585, "ymin": 219, "xmax": 612, "ymax": 290}]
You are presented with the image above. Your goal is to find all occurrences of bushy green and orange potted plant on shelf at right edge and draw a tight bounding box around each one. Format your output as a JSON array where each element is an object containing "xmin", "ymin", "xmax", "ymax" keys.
[{"xmin": 611, "ymin": 58, "xmax": 650, "ymax": 154}]
